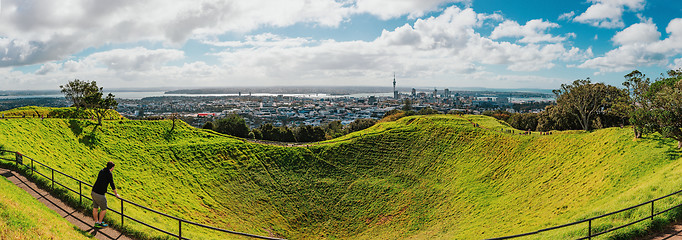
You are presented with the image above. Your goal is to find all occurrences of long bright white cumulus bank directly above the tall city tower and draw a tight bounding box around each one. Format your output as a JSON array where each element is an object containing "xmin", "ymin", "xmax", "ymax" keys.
[{"xmin": 212, "ymin": 7, "xmax": 585, "ymax": 81}]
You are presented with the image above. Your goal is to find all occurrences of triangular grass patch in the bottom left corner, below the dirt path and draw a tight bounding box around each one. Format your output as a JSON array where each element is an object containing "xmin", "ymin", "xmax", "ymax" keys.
[{"xmin": 0, "ymin": 173, "xmax": 93, "ymax": 240}]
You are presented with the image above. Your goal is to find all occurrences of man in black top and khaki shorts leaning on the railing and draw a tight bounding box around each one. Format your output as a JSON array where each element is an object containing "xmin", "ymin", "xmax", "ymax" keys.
[{"xmin": 90, "ymin": 162, "xmax": 121, "ymax": 228}]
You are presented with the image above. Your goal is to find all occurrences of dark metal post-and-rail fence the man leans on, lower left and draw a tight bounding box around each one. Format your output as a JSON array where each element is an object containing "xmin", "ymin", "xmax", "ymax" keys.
[{"xmin": 0, "ymin": 150, "xmax": 282, "ymax": 240}]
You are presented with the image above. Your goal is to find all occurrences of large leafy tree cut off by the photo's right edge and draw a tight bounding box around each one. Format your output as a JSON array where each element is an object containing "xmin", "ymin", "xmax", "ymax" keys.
[{"xmin": 630, "ymin": 69, "xmax": 682, "ymax": 148}]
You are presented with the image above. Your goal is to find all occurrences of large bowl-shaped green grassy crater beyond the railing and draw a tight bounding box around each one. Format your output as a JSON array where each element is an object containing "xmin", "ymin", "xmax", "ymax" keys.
[{"xmin": 0, "ymin": 108, "xmax": 682, "ymax": 239}]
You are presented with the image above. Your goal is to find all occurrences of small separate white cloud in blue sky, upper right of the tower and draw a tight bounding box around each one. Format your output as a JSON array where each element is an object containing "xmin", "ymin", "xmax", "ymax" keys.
[{"xmin": 490, "ymin": 19, "xmax": 566, "ymax": 43}]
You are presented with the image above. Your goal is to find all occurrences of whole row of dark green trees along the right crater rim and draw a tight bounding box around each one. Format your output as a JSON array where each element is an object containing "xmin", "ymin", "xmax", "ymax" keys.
[{"xmin": 483, "ymin": 69, "xmax": 682, "ymax": 148}]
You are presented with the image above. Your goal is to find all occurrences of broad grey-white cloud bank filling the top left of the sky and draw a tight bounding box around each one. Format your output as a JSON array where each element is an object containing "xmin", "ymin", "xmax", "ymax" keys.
[{"xmin": 0, "ymin": 0, "xmax": 478, "ymax": 67}]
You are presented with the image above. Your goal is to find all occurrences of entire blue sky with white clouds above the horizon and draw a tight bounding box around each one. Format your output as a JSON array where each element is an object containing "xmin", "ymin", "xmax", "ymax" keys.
[{"xmin": 0, "ymin": 0, "xmax": 682, "ymax": 90}]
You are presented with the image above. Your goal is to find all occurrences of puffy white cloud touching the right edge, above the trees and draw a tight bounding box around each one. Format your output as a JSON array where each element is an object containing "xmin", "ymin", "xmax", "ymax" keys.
[{"xmin": 578, "ymin": 18, "xmax": 682, "ymax": 73}]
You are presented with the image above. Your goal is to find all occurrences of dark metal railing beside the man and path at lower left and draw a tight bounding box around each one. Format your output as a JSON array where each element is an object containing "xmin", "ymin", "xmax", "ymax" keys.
[{"xmin": 0, "ymin": 150, "xmax": 282, "ymax": 240}]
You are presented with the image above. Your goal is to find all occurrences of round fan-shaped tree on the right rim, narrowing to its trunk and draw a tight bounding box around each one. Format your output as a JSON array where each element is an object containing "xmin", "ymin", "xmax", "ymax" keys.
[{"xmin": 553, "ymin": 78, "xmax": 625, "ymax": 131}]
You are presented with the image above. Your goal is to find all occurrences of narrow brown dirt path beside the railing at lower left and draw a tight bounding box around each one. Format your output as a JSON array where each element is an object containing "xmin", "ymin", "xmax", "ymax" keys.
[{"xmin": 0, "ymin": 168, "xmax": 132, "ymax": 240}]
